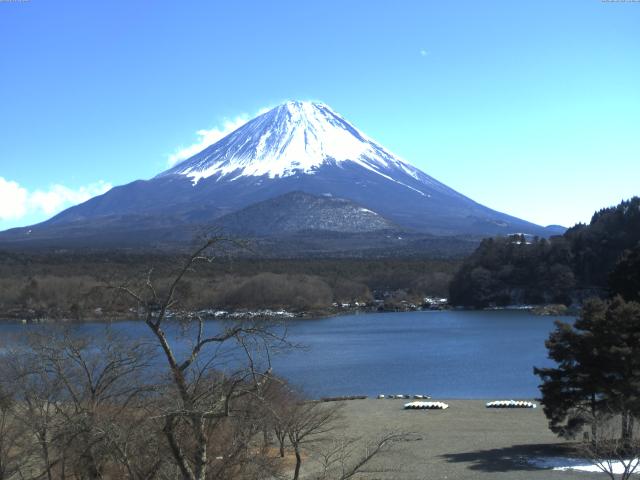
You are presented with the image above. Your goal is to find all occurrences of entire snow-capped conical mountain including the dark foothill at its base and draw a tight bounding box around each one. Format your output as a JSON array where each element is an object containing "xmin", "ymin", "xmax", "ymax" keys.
[{"xmin": 0, "ymin": 101, "xmax": 563, "ymax": 251}]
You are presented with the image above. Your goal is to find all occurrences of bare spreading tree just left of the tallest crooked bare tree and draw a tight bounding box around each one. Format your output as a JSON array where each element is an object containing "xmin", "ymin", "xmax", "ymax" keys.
[{"xmin": 40, "ymin": 332, "xmax": 154, "ymax": 479}]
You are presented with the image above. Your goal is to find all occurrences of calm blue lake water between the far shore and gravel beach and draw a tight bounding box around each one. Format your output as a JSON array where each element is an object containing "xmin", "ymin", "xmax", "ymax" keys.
[{"xmin": 0, "ymin": 310, "xmax": 571, "ymax": 398}]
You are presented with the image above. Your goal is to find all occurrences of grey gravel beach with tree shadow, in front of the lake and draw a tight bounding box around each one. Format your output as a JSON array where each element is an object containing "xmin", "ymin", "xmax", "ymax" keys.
[{"xmin": 320, "ymin": 399, "xmax": 606, "ymax": 480}]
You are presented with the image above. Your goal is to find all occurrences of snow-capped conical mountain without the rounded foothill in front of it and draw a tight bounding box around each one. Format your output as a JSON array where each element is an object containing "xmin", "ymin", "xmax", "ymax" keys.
[{"xmin": 0, "ymin": 102, "xmax": 561, "ymax": 249}]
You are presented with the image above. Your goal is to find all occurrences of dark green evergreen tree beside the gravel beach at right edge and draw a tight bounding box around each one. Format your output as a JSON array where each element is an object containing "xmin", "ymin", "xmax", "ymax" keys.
[{"xmin": 534, "ymin": 297, "xmax": 640, "ymax": 478}]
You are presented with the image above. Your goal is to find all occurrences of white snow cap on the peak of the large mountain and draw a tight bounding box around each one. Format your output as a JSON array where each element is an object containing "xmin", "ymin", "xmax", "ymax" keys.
[{"xmin": 159, "ymin": 101, "xmax": 430, "ymax": 186}]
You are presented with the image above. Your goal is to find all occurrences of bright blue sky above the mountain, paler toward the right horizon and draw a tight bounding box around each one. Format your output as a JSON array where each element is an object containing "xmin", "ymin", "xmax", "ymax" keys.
[{"xmin": 0, "ymin": 0, "xmax": 640, "ymax": 229}]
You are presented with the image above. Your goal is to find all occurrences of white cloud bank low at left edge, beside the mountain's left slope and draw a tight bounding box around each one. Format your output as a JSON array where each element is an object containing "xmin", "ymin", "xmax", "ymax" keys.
[{"xmin": 0, "ymin": 177, "xmax": 111, "ymax": 220}]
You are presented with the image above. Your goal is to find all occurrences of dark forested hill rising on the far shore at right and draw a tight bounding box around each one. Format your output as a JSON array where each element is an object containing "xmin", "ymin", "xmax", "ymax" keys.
[{"xmin": 450, "ymin": 197, "xmax": 640, "ymax": 307}]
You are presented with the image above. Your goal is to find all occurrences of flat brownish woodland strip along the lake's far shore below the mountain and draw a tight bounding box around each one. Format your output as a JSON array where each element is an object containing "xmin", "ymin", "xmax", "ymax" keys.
[{"xmin": 0, "ymin": 251, "xmax": 459, "ymax": 320}]
